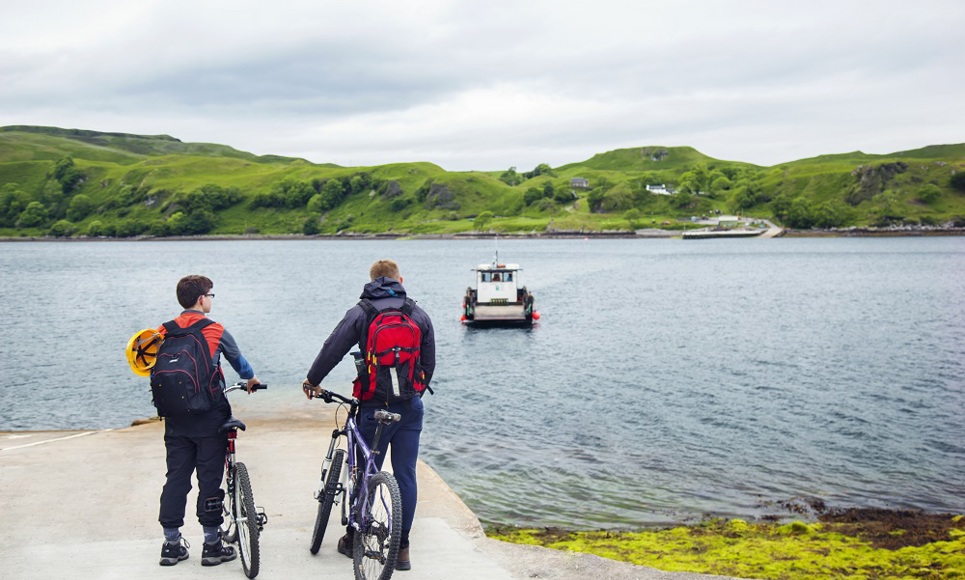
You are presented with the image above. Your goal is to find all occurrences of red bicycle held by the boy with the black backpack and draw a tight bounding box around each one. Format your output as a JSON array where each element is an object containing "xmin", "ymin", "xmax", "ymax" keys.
[{"xmin": 221, "ymin": 382, "xmax": 268, "ymax": 578}]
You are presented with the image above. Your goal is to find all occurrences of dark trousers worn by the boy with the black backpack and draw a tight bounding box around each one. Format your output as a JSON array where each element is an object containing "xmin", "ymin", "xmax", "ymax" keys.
[{"xmin": 158, "ymin": 433, "xmax": 228, "ymax": 528}]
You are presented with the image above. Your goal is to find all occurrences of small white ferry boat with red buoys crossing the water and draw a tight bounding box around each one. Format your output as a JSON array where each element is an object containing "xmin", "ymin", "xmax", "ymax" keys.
[{"xmin": 462, "ymin": 254, "xmax": 539, "ymax": 326}]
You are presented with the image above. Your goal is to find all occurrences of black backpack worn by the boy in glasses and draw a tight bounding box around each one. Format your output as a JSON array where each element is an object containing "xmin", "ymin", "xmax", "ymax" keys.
[{"xmin": 151, "ymin": 318, "xmax": 221, "ymax": 417}]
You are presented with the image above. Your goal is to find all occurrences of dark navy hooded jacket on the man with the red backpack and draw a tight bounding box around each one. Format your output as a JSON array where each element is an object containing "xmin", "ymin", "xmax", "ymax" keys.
[{"xmin": 308, "ymin": 277, "xmax": 436, "ymax": 394}]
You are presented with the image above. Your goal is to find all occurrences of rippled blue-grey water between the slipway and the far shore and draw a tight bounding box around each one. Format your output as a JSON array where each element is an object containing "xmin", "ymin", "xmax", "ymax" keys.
[{"xmin": 0, "ymin": 238, "xmax": 965, "ymax": 528}]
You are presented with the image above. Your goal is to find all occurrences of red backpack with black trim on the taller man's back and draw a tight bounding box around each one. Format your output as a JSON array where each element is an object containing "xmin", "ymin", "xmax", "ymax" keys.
[{"xmin": 352, "ymin": 298, "xmax": 426, "ymax": 403}]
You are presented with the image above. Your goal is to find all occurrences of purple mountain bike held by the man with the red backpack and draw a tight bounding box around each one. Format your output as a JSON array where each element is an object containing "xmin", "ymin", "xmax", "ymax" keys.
[{"xmin": 311, "ymin": 389, "xmax": 402, "ymax": 580}]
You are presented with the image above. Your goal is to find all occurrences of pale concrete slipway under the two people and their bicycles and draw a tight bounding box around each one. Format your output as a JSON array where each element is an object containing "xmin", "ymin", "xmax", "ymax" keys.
[{"xmin": 0, "ymin": 395, "xmax": 740, "ymax": 580}]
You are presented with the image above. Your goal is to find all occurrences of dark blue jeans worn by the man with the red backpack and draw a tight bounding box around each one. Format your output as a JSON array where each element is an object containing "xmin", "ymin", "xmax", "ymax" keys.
[{"xmin": 358, "ymin": 397, "xmax": 424, "ymax": 547}]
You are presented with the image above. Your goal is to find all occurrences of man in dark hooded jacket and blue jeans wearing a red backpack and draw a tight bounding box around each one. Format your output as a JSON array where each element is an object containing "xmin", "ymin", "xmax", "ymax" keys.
[{"xmin": 302, "ymin": 260, "xmax": 436, "ymax": 570}]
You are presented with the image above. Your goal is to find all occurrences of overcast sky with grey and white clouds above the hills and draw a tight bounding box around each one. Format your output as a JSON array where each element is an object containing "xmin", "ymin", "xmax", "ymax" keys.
[{"xmin": 0, "ymin": 0, "xmax": 965, "ymax": 171}]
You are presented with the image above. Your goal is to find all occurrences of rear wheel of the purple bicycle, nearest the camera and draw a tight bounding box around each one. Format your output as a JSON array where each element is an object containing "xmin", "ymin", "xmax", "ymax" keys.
[{"xmin": 353, "ymin": 471, "xmax": 402, "ymax": 580}]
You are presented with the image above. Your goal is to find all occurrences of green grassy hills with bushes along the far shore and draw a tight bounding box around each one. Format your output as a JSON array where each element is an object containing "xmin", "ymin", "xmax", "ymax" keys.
[{"xmin": 0, "ymin": 126, "xmax": 965, "ymax": 237}]
